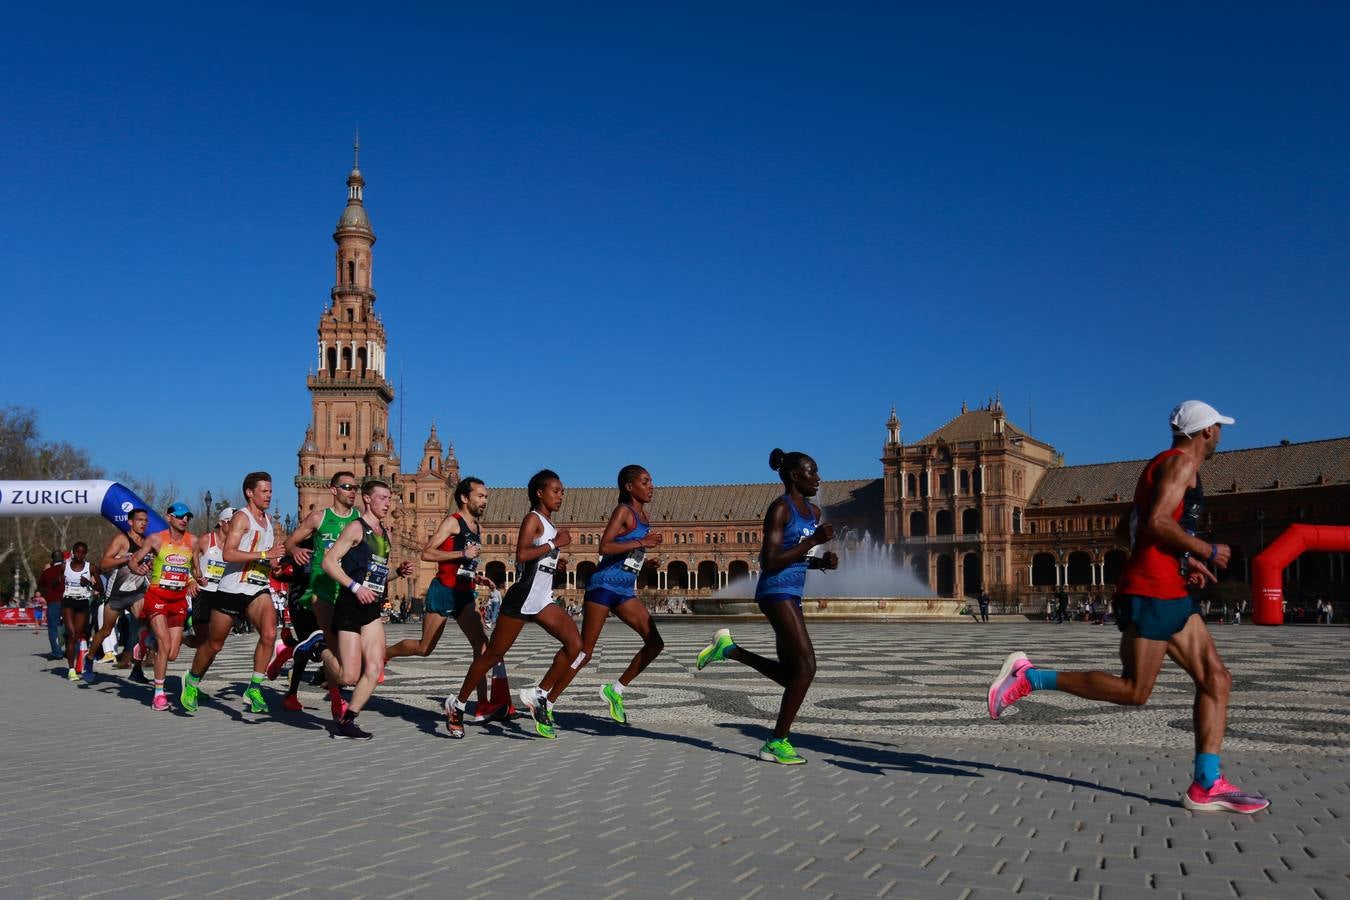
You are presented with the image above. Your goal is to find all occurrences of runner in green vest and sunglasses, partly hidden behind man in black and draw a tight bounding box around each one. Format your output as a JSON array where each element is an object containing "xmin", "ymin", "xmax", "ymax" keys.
[{"xmin": 282, "ymin": 471, "xmax": 360, "ymax": 722}]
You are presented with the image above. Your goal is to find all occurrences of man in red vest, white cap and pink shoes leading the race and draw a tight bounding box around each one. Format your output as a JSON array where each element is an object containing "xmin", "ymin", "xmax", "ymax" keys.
[{"xmin": 988, "ymin": 399, "xmax": 1270, "ymax": 814}]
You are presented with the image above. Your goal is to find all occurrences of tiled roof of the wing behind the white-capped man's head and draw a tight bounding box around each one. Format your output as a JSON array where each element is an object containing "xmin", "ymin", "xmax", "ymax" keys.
[{"xmin": 1030, "ymin": 437, "xmax": 1350, "ymax": 506}]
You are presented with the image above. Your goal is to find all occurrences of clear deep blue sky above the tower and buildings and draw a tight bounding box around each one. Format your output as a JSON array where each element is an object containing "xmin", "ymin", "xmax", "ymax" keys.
[{"xmin": 0, "ymin": 3, "xmax": 1350, "ymax": 511}]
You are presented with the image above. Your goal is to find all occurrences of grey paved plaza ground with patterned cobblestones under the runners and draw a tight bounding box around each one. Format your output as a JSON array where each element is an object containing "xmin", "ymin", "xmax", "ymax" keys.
[{"xmin": 0, "ymin": 619, "xmax": 1350, "ymax": 897}]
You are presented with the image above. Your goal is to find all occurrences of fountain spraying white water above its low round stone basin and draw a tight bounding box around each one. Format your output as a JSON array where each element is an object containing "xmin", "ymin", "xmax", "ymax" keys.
[{"xmin": 693, "ymin": 532, "xmax": 967, "ymax": 621}]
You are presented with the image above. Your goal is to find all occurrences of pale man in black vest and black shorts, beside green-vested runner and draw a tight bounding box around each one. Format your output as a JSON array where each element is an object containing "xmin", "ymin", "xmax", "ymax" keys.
[{"xmin": 323, "ymin": 479, "xmax": 413, "ymax": 738}]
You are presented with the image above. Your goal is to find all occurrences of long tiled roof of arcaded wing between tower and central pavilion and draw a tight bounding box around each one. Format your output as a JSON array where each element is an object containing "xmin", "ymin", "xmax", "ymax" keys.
[{"xmin": 483, "ymin": 478, "xmax": 882, "ymax": 525}]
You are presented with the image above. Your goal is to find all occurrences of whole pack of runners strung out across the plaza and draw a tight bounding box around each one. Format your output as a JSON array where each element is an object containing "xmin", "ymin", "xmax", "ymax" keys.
[{"xmin": 42, "ymin": 401, "xmax": 1269, "ymax": 812}]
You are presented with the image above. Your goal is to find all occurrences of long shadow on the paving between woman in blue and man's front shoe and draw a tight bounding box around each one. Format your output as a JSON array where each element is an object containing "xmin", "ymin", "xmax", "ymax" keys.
[{"xmin": 718, "ymin": 722, "xmax": 1181, "ymax": 807}]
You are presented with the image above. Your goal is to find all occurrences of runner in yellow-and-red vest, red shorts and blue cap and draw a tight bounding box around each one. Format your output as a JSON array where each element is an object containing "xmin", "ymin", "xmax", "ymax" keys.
[{"xmin": 128, "ymin": 502, "xmax": 197, "ymax": 710}]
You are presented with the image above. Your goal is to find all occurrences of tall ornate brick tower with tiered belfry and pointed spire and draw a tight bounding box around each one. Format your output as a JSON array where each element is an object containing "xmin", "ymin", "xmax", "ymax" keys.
[{"xmin": 296, "ymin": 140, "xmax": 400, "ymax": 515}]
